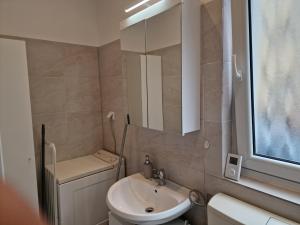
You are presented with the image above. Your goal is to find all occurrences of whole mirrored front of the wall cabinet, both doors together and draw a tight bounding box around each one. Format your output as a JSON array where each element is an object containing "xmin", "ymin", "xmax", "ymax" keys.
[{"xmin": 121, "ymin": 5, "xmax": 182, "ymax": 133}]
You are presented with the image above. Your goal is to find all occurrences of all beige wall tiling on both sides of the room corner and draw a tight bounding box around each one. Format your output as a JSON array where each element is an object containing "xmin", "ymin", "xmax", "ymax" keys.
[{"xmin": 1, "ymin": 0, "xmax": 300, "ymax": 225}]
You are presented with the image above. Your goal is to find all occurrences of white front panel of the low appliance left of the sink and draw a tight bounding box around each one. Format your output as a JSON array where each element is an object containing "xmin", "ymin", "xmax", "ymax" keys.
[{"xmin": 58, "ymin": 169, "xmax": 116, "ymax": 225}]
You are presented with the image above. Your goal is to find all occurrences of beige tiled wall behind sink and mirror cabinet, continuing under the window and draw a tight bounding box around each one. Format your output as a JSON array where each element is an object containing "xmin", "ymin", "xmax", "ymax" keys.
[{"xmin": 99, "ymin": 0, "xmax": 300, "ymax": 221}]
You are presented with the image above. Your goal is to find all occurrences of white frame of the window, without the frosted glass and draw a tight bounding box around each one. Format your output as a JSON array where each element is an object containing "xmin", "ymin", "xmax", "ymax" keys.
[{"xmin": 232, "ymin": 0, "xmax": 300, "ymax": 183}]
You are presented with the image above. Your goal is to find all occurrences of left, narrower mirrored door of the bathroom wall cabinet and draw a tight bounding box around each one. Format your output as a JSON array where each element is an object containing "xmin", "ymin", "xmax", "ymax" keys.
[{"xmin": 121, "ymin": 21, "xmax": 148, "ymax": 128}]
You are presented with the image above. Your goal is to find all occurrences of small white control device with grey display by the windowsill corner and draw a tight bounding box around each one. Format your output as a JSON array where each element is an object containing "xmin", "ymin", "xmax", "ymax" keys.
[{"xmin": 225, "ymin": 153, "xmax": 242, "ymax": 181}]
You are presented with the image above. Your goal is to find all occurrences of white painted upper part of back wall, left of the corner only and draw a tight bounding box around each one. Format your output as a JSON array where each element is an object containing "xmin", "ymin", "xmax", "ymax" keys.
[{"xmin": 0, "ymin": 0, "xmax": 101, "ymax": 46}]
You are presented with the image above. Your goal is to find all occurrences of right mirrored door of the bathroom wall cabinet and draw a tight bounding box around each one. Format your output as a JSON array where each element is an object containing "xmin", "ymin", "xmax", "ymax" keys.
[{"xmin": 146, "ymin": 5, "xmax": 182, "ymax": 134}]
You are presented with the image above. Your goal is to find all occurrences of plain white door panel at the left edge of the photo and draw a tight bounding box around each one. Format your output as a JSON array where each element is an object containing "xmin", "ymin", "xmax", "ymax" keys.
[{"xmin": 0, "ymin": 39, "xmax": 38, "ymax": 209}]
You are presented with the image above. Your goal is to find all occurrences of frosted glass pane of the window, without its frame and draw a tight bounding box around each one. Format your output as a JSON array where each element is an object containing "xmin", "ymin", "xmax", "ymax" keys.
[{"xmin": 250, "ymin": 0, "xmax": 300, "ymax": 164}]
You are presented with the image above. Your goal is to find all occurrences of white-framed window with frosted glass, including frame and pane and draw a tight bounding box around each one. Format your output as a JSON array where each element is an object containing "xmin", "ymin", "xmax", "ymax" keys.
[{"xmin": 233, "ymin": 0, "xmax": 300, "ymax": 182}]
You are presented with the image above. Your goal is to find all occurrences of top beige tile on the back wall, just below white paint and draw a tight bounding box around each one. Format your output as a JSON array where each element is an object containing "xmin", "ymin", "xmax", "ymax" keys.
[{"xmin": 26, "ymin": 39, "xmax": 98, "ymax": 76}]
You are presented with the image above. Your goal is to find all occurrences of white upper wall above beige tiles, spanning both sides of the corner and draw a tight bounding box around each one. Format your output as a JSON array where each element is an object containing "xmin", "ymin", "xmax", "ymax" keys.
[{"xmin": 0, "ymin": 0, "xmax": 211, "ymax": 46}]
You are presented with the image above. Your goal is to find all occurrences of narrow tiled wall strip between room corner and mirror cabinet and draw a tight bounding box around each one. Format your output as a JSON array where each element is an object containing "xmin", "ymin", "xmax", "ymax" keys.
[{"xmin": 99, "ymin": 41, "xmax": 127, "ymax": 151}]
